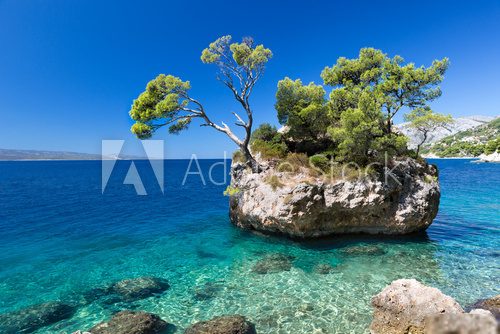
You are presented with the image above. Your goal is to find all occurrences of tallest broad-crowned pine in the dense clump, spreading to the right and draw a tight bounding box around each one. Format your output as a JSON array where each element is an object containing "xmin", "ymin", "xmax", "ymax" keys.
[{"xmin": 321, "ymin": 48, "xmax": 449, "ymax": 133}]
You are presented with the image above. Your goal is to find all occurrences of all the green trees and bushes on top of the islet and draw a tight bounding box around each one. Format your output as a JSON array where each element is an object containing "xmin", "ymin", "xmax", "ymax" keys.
[{"xmin": 130, "ymin": 42, "xmax": 450, "ymax": 171}]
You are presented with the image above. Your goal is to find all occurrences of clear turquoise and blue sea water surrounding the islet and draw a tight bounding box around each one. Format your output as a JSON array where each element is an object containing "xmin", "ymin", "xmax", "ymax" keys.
[{"xmin": 0, "ymin": 160, "xmax": 500, "ymax": 333}]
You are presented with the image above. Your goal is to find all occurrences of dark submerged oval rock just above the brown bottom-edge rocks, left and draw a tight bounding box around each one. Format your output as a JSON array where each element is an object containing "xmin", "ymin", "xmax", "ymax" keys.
[{"xmin": 110, "ymin": 277, "xmax": 170, "ymax": 301}]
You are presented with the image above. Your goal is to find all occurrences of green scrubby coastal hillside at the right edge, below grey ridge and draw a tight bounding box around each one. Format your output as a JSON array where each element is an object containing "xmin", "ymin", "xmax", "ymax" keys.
[{"xmin": 422, "ymin": 117, "xmax": 500, "ymax": 158}]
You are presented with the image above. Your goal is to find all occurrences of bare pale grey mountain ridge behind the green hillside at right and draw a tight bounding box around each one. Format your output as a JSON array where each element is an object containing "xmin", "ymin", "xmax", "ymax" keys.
[{"xmin": 396, "ymin": 116, "xmax": 495, "ymax": 148}]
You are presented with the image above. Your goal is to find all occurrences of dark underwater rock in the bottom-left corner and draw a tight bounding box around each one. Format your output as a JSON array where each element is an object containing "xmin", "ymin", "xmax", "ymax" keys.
[{"xmin": 0, "ymin": 301, "xmax": 75, "ymax": 334}]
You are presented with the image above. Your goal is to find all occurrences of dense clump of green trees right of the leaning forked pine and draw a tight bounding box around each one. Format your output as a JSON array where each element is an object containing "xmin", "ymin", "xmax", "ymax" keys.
[{"xmin": 275, "ymin": 48, "xmax": 448, "ymax": 164}]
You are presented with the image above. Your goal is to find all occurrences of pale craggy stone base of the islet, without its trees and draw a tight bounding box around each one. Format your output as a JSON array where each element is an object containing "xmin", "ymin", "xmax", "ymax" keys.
[{"xmin": 230, "ymin": 158, "xmax": 440, "ymax": 238}]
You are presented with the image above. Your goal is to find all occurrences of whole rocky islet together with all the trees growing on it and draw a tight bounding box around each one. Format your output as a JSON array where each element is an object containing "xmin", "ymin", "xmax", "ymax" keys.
[{"xmin": 130, "ymin": 36, "xmax": 451, "ymax": 237}]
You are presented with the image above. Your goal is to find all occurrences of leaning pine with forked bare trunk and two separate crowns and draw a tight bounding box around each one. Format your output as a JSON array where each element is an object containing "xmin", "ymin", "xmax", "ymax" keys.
[{"xmin": 130, "ymin": 36, "xmax": 272, "ymax": 172}]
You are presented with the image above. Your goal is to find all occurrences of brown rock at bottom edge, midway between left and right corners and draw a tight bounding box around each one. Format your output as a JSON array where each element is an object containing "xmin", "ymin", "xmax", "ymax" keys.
[{"xmin": 184, "ymin": 315, "xmax": 256, "ymax": 334}]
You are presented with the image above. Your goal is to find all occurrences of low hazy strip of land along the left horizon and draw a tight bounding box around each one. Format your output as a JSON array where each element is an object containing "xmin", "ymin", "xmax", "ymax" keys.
[{"xmin": 0, "ymin": 148, "xmax": 143, "ymax": 160}]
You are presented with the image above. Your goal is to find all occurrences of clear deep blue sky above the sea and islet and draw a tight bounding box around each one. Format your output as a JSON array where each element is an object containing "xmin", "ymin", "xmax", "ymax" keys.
[{"xmin": 0, "ymin": 0, "xmax": 500, "ymax": 158}]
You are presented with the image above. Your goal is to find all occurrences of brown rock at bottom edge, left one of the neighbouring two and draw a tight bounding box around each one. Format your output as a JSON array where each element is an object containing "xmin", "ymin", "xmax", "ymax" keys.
[{"xmin": 90, "ymin": 311, "xmax": 169, "ymax": 334}]
